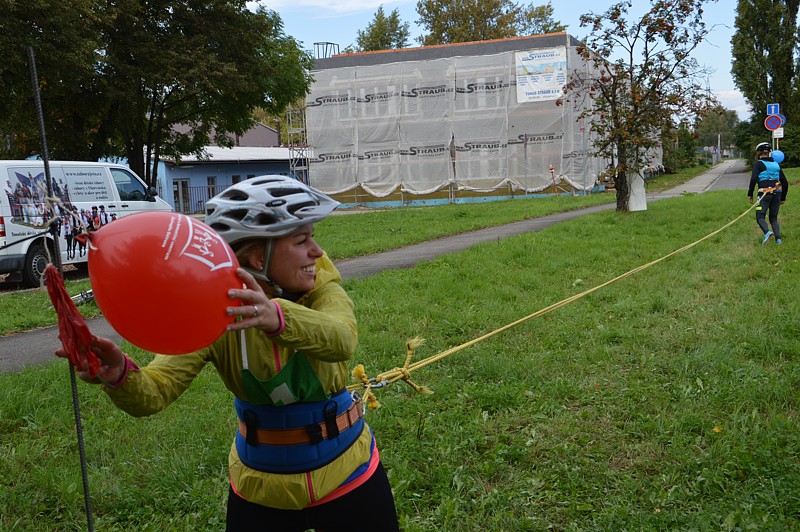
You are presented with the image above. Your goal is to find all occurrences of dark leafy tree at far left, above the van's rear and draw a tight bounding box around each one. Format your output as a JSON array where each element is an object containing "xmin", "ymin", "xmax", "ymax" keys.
[{"xmin": 0, "ymin": 0, "xmax": 109, "ymax": 161}]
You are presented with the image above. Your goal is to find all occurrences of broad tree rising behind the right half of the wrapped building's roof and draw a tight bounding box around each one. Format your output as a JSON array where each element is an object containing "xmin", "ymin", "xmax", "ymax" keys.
[{"xmin": 417, "ymin": 0, "xmax": 566, "ymax": 46}]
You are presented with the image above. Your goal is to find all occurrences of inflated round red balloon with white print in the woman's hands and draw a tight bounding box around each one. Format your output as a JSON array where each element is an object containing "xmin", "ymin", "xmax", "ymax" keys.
[{"xmin": 89, "ymin": 212, "xmax": 242, "ymax": 355}]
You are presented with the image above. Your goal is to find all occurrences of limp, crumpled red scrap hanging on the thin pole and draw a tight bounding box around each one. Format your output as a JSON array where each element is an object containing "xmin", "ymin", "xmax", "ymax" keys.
[{"xmin": 44, "ymin": 264, "xmax": 100, "ymax": 377}]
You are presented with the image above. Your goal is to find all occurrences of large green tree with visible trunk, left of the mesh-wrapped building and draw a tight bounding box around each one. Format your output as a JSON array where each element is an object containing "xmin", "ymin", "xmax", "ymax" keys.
[{"xmin": 102, "ymin": 0, "xmax": 312, "ymax": 186}]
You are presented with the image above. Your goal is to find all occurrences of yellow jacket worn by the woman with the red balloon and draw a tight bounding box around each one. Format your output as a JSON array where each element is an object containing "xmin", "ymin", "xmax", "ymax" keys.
[{"xmin": 105, "ymin": 255, "xmax": 372, "ymax": 509}]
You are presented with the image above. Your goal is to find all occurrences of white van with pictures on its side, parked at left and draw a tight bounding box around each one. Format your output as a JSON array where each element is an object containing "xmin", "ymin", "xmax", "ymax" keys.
[{"xmin": 0, "ymin": 161, "xmax": 172, "ymax": 287}]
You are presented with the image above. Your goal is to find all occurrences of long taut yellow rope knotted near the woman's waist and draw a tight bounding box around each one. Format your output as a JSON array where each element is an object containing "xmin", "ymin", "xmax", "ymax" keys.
[{"xmin": 347, "ymin": 202, "xmax": 759, "ymax": 408}]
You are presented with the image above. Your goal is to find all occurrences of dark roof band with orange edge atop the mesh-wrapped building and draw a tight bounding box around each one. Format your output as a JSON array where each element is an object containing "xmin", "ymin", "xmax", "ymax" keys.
[{"xmin": 314, "ymin": 32, "xmax": 580, "ymax": 70}]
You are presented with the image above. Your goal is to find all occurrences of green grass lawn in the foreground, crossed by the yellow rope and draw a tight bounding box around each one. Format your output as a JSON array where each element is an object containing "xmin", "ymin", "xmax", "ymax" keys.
[{"xmin": 0, "ymin": 164, "xmax": 800, "ymax": 531}]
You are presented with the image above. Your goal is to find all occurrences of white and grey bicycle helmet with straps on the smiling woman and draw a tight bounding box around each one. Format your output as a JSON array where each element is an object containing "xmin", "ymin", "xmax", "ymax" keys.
[{"xmin": 205, "ymin": 175, "xmax": 339, "ymax": 297}]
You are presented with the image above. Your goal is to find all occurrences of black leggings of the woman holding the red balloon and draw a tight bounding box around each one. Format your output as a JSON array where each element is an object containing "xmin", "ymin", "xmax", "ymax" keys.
[{"xmin": 226, "ymin": 463, "xmax": 400, "ymax": 532}]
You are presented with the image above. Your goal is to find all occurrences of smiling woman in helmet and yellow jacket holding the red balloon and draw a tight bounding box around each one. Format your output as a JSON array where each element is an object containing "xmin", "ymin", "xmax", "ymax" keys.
[{"xmin": 57, "ymin": 176, "xmax": 398, "ymax": 531}]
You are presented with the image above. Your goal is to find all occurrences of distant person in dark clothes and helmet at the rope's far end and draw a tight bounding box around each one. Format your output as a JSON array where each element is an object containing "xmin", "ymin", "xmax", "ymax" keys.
[{"xmin": 747, "ymin": 142, "xmax": 789, "ymax": 245}]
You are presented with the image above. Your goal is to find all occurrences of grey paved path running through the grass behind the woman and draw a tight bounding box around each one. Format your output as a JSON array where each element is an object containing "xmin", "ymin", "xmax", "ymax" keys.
[{"xmin": 0, "ymin": 160, "xmax": 750, "ymax": 371}]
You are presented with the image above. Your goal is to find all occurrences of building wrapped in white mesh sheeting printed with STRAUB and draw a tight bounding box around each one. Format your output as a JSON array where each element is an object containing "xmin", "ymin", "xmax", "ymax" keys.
[{"xmin": 304, "ymin": 33, "xmax": 605, "ymax": 203}]
